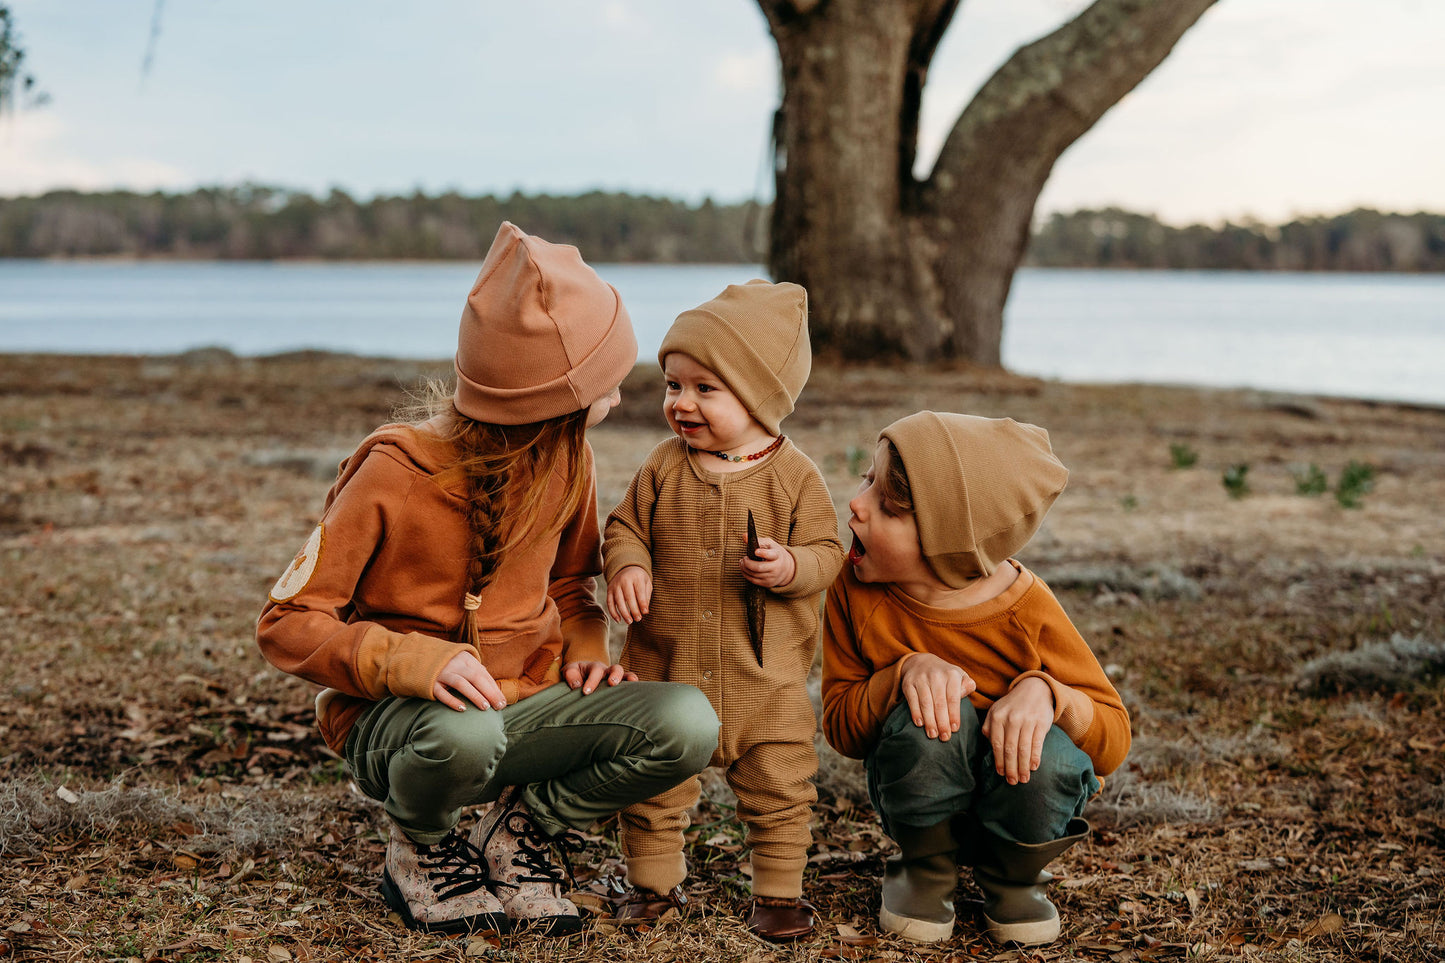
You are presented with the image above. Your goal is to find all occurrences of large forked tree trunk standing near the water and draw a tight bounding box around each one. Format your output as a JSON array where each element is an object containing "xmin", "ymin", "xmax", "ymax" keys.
[{"xmin": 759, "ymin": 0, "xmax": 1214, "ymax": 366}]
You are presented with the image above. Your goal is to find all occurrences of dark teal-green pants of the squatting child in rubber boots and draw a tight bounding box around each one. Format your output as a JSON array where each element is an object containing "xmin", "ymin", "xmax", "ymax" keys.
[{"xmin": 864, "ymin": 700, "xmax": 1100, "ymax": 843}]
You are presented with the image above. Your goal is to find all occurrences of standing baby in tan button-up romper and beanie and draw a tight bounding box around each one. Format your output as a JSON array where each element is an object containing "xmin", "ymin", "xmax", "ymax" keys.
[{"xmin": 603, "ymin": 281, "xmax": 842, "ymax": 940}]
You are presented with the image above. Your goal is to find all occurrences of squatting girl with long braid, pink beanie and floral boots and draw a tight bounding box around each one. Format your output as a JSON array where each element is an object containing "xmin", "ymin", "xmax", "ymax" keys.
[{"xmin": 256, "ymin": 224, "xmax": 718, "ymax": 933}]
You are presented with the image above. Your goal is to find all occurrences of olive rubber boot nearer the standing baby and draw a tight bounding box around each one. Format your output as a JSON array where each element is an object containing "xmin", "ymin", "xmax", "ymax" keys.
[{"xmin": 879, "ymin": 820, "xmax": 958, "ymax": 943}]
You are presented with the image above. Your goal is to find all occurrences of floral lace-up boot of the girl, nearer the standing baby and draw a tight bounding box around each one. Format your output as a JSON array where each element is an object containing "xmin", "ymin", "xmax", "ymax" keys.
[{"xmin": 471, "ymin": 787, "xmax": 582, "ymax": 936}]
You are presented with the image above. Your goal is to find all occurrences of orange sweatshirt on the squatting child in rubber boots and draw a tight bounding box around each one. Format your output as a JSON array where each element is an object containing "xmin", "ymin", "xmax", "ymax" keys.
[{"xmin": 822, "ymin": 560, "xmax": 1130, "ymax": 776}]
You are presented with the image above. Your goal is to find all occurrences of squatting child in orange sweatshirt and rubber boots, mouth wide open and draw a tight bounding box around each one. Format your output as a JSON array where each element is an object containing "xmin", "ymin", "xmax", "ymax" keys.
[{"xmin": 822, "ymin": 411, "xmax": 1130, "ymax": 944}]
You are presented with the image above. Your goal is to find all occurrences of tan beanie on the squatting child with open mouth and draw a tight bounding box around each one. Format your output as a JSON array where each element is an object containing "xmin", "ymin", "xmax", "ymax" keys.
[{"xmin": 880, "ymin": 411, "xmax": 1069, "ymax": 589}]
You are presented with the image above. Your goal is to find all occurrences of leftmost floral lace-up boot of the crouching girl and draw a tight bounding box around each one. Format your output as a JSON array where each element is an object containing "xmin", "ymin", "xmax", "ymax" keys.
[{"xmin": 381, "ymin": 823, "xmax": 507, "ymax": 933}]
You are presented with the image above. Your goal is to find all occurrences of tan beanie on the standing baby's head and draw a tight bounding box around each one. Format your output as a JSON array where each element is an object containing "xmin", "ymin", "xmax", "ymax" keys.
[{"xmin": 657, "ymin": 279, "xmax": 812, "ymax": 435}]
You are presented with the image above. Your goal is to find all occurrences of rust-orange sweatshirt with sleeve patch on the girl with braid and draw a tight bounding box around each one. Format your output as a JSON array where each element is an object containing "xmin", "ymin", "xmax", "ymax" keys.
[{"xmin": 256, "ymin": 425, "xmax": 610, "ymax": 752}]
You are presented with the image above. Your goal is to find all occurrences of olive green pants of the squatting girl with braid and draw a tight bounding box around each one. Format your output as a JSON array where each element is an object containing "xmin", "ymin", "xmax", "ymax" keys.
[{"xmin": 345, "ymin": 673, "xmax": 718, "ymax": 843}]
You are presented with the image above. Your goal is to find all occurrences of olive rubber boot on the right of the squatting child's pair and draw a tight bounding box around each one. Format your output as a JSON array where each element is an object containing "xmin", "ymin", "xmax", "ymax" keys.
[{"xmin": 974, "ymin": 818, "xmax": 1090, "ymax": 944}]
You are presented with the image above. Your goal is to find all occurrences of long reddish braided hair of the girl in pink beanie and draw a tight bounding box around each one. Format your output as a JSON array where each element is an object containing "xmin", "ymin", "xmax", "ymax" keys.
[{"xmin": 400, "ymin": 380, "xmax": 591, "ymax": 645}]
